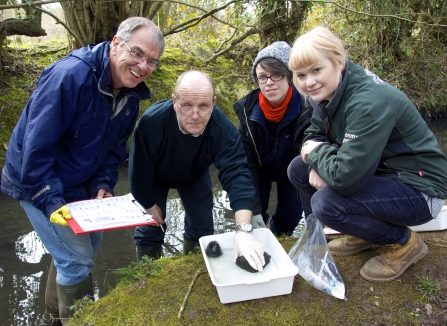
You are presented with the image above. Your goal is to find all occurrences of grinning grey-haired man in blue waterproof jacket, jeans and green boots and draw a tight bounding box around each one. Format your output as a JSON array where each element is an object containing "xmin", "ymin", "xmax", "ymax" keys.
[{"xmin": 1, "ymin": 17, "xmax": 165, "ymax": 325}]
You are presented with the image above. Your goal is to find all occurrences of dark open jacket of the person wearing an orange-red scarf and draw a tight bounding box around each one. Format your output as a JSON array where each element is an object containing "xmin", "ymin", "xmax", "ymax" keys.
[{"xmin": 233, "ymin": 85, "xmax": 312, "ymax": 214}]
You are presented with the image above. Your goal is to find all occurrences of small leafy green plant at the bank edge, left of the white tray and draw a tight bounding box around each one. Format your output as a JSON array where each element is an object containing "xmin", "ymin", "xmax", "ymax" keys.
[{"xmin": 113, "ymin": 256, "xmax": 161, "ymax": 286}]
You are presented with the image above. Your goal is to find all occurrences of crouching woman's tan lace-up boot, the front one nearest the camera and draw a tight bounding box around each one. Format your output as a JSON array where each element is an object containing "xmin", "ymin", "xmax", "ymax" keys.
[{"xmin": 360, "ymin": 230, "xmax": 428, "ymax": 282}]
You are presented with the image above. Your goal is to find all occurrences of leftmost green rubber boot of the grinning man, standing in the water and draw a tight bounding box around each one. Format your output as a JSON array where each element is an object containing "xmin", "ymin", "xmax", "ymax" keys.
[{"xmin": 40, "ymin": 260, "xmax": 62, "ymax": 326}]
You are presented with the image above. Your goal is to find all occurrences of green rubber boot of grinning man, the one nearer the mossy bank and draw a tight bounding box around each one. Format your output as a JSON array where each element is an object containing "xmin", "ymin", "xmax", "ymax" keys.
[{"xmin": 56, "ymin": 276, "xmax": 93, "ymax": 325}]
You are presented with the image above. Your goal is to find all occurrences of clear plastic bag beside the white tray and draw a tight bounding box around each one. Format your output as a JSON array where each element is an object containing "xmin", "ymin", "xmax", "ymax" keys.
[{"xmin": 289, "ymin": 214, "xmax": 347, "ymax": 300}]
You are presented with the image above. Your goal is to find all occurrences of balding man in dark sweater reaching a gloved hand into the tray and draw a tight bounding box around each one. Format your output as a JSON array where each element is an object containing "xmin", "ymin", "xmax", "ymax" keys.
[{"xmin": 129, "ymin": 71, "xmax": 265, "ymax": 271}]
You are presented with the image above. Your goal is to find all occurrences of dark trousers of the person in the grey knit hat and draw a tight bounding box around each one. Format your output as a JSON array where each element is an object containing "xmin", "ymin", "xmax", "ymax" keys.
[{"xmin": 259, "ymin": 166, "xmax": 303, "ymax": 235}]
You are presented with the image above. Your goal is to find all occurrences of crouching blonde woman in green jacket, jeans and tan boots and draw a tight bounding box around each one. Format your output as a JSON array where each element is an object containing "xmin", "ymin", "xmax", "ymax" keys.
[{"xmin": 288, "ymin": 27, "xmax": 447, "ymax": 282}]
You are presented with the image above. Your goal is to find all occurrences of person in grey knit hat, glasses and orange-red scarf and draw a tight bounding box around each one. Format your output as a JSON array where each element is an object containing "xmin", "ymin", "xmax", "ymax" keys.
[{"xmin": 233, "ymin": 41, "xmax": 312, "ymax": 235}]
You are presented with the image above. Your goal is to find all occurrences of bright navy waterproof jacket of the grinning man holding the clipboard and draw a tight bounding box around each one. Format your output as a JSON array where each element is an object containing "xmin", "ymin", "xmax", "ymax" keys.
[{"xmin": 1, "ymin": 42, "xmax": 150, "ymax": 217}]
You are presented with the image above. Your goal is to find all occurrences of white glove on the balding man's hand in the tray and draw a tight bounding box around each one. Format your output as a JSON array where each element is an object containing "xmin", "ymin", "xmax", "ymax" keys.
[{"xmin": 233, "ymin": 232, "xmax": 265, "ymax": 272}]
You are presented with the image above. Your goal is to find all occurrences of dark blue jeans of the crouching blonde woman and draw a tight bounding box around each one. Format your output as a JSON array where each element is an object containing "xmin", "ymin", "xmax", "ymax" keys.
[{"xmin": 288, "ymin": 156, "xmax": 433, "ymax": 245}]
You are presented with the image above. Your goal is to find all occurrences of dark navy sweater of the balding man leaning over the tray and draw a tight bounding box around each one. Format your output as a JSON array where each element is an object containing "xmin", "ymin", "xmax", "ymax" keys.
[{"xmin": 129, "ymin": 100, "xmax": 255, "ymax": 211}]
